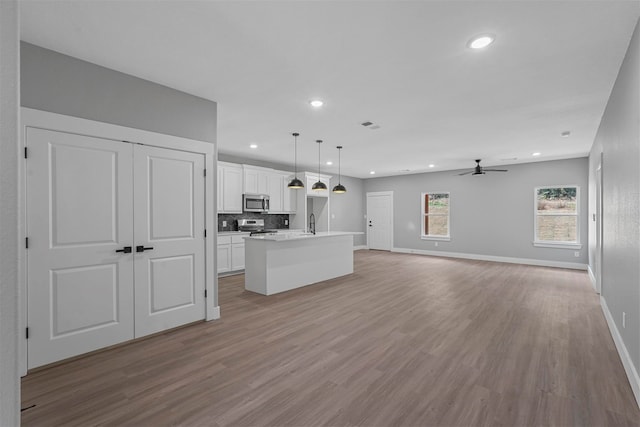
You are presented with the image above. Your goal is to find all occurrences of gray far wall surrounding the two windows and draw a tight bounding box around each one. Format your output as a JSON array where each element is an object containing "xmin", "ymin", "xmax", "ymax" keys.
[{"xmin": 364, "ymin": 157, "xmax": 588, "ymax": 265}]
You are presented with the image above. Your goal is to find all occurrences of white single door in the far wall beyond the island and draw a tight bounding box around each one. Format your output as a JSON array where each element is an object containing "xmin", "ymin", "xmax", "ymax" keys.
[{"xmin": 367, "ymin": 191, "xmax": 393, "ymax": 251}]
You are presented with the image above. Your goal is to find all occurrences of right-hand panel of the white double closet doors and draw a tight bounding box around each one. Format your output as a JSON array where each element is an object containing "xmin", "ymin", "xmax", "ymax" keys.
[{"xmin": 133, "ymin": 145, "xmax": 205, "ymax": 337}]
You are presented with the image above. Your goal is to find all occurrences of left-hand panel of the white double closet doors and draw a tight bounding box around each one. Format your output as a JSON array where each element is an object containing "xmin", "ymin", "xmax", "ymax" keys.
[{"xmin": 26, "ymin": 128, "xmax": 133, "ymax": 368}]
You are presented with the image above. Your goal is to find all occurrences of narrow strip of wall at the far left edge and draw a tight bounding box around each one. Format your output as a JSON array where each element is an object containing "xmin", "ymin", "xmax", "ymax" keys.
[{"xmin": 0, "ymin": 0, "xmax": 20, "ymax": 426}]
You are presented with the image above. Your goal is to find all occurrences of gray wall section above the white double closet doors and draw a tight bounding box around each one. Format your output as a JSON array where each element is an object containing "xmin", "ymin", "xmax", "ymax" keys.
[{"xmin": 20, "ymin": 42, "xmax": 217, "ymax": 142}]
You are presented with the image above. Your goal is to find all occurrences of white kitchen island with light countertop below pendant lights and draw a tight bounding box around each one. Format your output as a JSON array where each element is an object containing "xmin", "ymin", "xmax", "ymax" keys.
[{"xmin": 244, "ymin": 231, "xmax": 362, "ymax": 295}]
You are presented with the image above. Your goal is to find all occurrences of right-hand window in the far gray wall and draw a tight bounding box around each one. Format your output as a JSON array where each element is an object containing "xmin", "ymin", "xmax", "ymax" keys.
[{"xmin": 534, "ymin": 187, "xmax": 580, "ymax": 248}]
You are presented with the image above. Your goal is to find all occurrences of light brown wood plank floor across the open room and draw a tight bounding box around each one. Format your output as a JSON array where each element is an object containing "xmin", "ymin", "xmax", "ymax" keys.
[{"xmin": 22, "ymin": 251, "xmax": 640, "ymax": 426}]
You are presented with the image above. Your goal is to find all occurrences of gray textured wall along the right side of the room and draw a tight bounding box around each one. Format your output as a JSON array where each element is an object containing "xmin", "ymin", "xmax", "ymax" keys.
[{"xmin": 589, "ymin": 21, "xmax": 640, "ymax": 382}]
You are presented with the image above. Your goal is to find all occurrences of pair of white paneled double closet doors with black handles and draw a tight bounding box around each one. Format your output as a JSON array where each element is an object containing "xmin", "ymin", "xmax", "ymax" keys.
[{"xmin": 26, "ymin": 128, "xmax": 205, "ymax": 368}]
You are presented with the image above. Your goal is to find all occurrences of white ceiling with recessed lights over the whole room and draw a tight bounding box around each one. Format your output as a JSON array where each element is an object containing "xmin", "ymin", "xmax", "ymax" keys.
[{"xmin": 21, "ymin": 0, "xmax": 640, "ymax": 178}]
